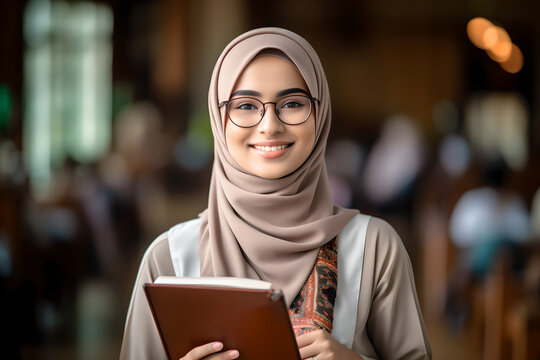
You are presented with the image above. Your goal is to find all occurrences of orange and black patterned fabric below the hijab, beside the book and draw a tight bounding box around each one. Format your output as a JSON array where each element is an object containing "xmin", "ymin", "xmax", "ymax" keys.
[{"xmin": 289, "ymin": 238, "xmax": 337, "ymax": 336}]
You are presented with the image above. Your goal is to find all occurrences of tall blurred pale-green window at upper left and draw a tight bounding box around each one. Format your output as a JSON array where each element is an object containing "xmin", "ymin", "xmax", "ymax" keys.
[{"xmin": 24, "ymin": 0, "xmax": 113, "ymax": 198}]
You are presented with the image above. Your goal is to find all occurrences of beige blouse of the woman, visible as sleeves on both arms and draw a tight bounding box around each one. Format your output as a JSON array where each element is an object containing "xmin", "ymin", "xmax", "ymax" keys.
[{"xmin": 120, "ymin": 218, "xmax": 431, "ymax": 359}]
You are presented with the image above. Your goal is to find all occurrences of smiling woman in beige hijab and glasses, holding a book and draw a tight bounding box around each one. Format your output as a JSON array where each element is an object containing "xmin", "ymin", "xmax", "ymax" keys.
[{"xmin": 121, "ymin": 28, "xmax": 431, "ymax": 360}]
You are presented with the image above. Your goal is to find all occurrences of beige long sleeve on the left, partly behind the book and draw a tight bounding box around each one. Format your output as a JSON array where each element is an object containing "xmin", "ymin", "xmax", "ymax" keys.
[{"xmin": 120, "ymin": 233, "xmax": 174, "ymax": 360}]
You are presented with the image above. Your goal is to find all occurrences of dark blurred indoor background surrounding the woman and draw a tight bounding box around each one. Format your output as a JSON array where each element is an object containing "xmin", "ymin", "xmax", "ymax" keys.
[{"xmin": 0, "ymin": 0, "xmax": 540, "ymax": 360}]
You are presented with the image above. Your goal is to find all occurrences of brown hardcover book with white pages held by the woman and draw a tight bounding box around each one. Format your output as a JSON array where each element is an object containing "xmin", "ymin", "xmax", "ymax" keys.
[{"xmin": 143, "ymin": 277, "xmax": 300, "ymax": 360}]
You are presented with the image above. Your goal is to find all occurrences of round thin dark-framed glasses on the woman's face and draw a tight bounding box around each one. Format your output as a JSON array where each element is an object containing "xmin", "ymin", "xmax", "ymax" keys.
[{"xmin": 219, "ymin": 95, "xmax": 320, "ymax": 128}]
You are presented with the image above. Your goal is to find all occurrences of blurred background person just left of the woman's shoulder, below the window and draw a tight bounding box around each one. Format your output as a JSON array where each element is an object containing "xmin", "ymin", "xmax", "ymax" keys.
[{"xmin": 83, "ymin": 101, "xmax": 170, "ymax": 269}]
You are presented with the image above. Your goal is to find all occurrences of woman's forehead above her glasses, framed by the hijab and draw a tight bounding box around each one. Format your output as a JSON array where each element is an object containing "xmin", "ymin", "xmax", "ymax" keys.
[{"xmin": 232, "ymin": 55, "xmax": 308, "ymax": 96}]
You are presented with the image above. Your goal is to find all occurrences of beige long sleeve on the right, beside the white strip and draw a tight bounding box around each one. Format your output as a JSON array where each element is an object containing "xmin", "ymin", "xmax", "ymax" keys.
[{"xmin": 353, "ymin": 218, "xmax": 431, "ymax": 360}]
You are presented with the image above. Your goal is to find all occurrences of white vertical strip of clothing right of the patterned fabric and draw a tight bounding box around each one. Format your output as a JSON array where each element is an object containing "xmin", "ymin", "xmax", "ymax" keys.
[{"xmin": 332, "ymin": 214, "xmax": 371, "ymax": 349}]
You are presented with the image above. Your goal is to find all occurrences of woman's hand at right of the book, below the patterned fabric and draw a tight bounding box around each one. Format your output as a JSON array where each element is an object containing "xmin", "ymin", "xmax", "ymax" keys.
[{"xmin": 296, "ymin": 329, "xmax": 362, "ymax": 360}]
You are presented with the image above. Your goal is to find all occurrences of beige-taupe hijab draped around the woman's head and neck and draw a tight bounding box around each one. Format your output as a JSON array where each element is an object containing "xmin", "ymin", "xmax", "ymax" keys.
[{"xmin": 199, "ymin": 28, "xmax": 357, "ymax": 305}]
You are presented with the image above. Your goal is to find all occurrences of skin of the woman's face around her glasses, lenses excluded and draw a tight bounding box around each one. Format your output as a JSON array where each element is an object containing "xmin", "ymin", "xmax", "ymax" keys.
[{"xmin": 222, "ymin": 56, "xmax": 315, "ymax": 179}]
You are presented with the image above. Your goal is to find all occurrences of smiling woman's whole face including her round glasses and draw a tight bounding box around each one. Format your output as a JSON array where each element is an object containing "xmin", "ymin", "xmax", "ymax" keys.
[{"xmin": 224, "ymin": 55, "xmax": 315, "ymax": 179}]
